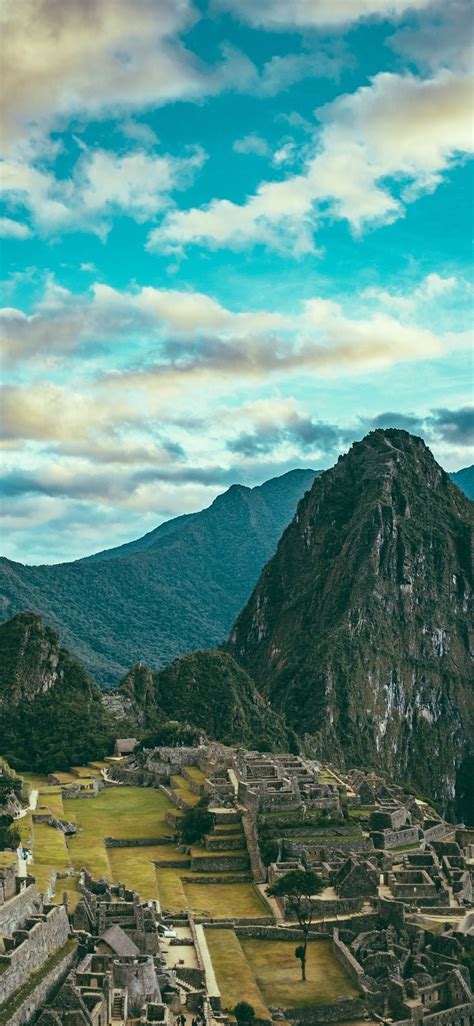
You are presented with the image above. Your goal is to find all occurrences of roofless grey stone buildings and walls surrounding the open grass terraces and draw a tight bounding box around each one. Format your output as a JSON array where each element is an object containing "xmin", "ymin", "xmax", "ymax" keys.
[{"xmin": 0, "ymin": 739, "xmax": 474, "ymax": 1026}]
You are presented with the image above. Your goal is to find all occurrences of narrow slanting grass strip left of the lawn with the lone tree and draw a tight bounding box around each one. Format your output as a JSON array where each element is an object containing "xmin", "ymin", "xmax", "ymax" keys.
[{"xmin": 205, "ymin": 930, "xmax": 272, "ymax": 1021}]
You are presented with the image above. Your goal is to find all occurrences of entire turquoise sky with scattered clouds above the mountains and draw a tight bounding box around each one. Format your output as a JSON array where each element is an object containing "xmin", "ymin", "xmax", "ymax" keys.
[{"xmin": 0, "ymin": 0, "xmax": 473, "ymax": 563}]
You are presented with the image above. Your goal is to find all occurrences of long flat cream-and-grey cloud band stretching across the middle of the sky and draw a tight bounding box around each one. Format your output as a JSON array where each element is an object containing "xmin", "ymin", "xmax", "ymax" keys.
[{"xmin": 0, "ymin": 282, "xmax": 467, "ymax": 390}]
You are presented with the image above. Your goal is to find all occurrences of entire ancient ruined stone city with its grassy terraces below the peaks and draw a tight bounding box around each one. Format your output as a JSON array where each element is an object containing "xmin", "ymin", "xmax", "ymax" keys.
[{"xmin": 0, "ymin": 739, "xmax": 474, "ymax": 1026}]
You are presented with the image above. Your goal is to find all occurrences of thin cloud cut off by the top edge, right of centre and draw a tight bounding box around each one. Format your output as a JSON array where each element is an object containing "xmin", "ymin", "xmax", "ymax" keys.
[{"xmin": 214, "ymin": 0, "xmax": 432, "ymax": 31}]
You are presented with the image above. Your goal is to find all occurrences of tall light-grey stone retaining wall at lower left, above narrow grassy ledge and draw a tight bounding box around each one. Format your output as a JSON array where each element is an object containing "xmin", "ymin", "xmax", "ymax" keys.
[{"xmin": 0, "ymin": 905, "xmax": 70, "ymax": 1005}]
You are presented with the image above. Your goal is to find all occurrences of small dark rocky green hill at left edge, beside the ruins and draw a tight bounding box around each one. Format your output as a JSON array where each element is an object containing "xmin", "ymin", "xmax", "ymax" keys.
[{"xmin": 0, "ymin": 613, "xmax": 117, "ymax": 773}]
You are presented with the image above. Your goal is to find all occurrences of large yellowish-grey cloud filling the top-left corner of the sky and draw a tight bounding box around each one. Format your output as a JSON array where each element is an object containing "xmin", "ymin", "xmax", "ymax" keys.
[{"xmin": 1, "ymin": 0, "xmax": 248, "ymax": 151}]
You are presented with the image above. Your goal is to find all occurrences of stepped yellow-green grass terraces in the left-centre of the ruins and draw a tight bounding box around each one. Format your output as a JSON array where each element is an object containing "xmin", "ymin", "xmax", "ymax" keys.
[{"xmin": 18, "ymin": 765, "xmax": 269, "ymax": 919}]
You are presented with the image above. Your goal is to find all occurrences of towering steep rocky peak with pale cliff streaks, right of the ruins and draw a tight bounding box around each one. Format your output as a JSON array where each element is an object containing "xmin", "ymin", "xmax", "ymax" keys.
[{"xmin": 228, "ymin": 430, "xmax": 474, "ymax": 803}]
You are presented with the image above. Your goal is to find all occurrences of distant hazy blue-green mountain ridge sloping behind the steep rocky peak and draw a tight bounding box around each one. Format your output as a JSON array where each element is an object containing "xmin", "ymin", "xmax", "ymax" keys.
[{"xmin": 0, "ymin": 470, "xmax": 314, "ymax": 685}]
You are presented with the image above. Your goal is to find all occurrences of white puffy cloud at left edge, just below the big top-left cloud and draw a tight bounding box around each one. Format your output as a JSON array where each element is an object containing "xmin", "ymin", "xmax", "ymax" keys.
[{"xmin": 0, "ymin": 147, "xmax": 206, "ymax": 235}]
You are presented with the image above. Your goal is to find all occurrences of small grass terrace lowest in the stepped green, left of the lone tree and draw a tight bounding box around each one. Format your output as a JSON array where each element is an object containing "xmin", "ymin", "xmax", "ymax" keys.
[{"xmin": 183, "ymin": 881, "xmax": 271, "ymax": 919}]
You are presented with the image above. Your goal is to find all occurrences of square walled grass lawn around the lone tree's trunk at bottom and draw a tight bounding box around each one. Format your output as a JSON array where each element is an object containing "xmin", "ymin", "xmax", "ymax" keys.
[{"xmin": 241, "ymin": 937, "xmax": 358, "ymax": 1009}]
